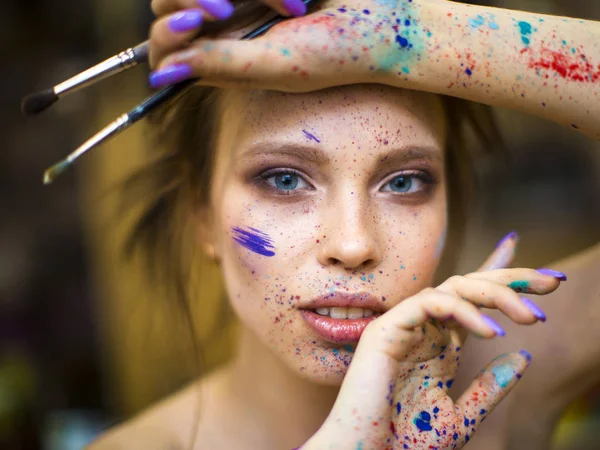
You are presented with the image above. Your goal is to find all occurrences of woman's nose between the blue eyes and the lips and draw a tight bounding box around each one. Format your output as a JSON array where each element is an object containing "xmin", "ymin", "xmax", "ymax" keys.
[{"xmin": 317, "ymin": 197, "xmax": 382, "ymax": 271}]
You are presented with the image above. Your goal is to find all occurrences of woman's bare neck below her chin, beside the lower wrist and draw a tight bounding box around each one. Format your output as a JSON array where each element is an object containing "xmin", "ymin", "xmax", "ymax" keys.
[{"xmin": 226, "ymin": 327, "xmax": 339, "ymax": 449}]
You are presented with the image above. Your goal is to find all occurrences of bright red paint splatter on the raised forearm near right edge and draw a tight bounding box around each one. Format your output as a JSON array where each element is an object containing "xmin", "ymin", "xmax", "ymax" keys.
[{"xmin": 521, "ymin": 48, "xmax": 600, "ymax": 83}]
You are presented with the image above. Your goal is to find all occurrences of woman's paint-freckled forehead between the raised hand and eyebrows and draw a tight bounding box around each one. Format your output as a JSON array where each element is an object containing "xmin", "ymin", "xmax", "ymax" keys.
[{"xmin": 219, "ymin": 85, "xmax": 445, "ymax": 163}]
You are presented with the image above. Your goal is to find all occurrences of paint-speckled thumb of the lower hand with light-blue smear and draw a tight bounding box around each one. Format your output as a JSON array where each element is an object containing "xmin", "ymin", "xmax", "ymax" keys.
[{"xmin": 456, "ymin": 350, "xmax": 531, "ymax": 447}]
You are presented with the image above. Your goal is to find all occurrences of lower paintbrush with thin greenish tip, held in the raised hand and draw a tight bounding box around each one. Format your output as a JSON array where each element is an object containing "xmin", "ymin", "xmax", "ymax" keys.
[{"xmin": 44, "ymin": 0, "xmax": 316, "ymax": 184}]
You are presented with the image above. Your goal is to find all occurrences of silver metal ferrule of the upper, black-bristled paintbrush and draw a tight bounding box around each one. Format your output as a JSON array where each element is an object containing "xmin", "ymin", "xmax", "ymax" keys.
[{"xmin": 53, "ymin": 47, "xmax": 145, "ymax": 95}]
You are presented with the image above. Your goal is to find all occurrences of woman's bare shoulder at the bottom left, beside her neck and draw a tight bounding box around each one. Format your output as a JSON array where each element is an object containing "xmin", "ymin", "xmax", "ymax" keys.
[{"xmin": 86, "ymin": 383, "xmax": 200, "ymax": 450}]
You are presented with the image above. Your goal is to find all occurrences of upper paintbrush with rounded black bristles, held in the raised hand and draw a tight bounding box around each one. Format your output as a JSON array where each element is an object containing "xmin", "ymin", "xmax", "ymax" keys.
[{"xmin": 21, "ymin": 0, "xmax": 269, "ymax": 116}]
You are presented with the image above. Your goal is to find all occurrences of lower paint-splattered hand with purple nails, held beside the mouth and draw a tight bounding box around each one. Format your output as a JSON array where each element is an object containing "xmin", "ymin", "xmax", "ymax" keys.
[{"xmin": 302, "ymin": 232, "xmax": 564, "ymax": 450}]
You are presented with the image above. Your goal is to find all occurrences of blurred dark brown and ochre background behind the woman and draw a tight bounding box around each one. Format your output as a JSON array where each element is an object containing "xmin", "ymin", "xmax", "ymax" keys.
[{"xmin": 0, "ymin": 0, "xmax": 600, "ymax": 450}]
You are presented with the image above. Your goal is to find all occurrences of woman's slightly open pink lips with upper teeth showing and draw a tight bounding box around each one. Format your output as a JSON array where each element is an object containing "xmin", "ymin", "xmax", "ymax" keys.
[{"xmin": 300, "ymin": 292, "xmax": 385, "ymax": 344}]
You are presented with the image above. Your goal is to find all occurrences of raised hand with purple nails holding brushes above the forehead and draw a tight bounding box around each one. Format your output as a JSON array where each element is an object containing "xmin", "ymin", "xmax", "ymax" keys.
[{"xmin": 150, "ymin": 0, "xmax": 414, "ymax": 91}]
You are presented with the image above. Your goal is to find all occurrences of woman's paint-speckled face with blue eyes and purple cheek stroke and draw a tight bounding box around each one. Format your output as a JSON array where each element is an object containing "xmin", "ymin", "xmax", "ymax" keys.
[{"xmin": 206, "ymin": 85, "xmax": 446, "ymax": 385}]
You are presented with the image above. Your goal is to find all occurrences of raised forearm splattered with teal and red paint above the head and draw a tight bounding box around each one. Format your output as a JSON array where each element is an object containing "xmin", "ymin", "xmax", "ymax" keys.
[{"xmin": 384, "ymin": 0, "xmax": 600, "ymax": 139}]
